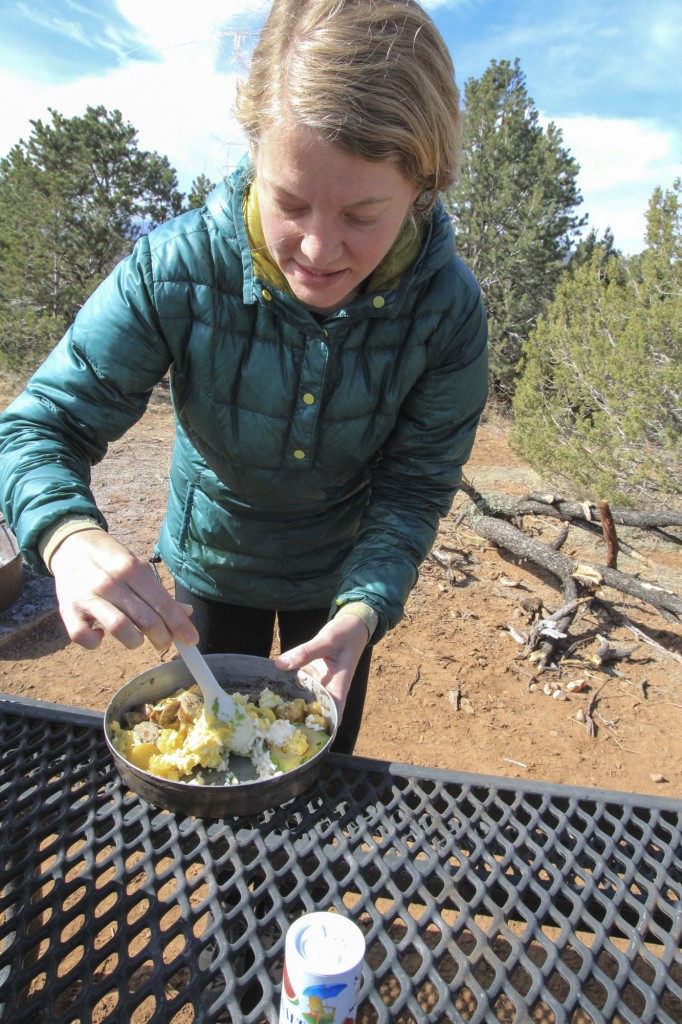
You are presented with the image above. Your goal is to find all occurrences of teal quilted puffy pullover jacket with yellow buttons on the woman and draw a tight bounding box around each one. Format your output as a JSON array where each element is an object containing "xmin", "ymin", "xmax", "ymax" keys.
[{"xmin": 0, "ymin": 160, "xmax": 487, "ymax": 642}]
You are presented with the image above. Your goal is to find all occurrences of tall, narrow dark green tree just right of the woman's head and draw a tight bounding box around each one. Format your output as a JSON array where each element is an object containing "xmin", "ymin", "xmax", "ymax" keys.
[{"xmin": 446, "ymin": 59, "xmax": 584, "ymax": 398}]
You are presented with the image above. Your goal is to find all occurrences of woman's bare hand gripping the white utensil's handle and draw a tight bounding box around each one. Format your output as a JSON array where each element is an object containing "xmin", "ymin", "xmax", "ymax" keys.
[{"xmin": 50, "ymin": 529, "xmax": 199, "ymax": 651}]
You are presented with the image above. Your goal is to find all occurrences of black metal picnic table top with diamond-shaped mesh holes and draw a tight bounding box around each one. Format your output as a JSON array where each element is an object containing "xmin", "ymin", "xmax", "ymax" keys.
[{"xmin": 0, "ymin": 695, "xmax": 682, "ymax": 1024}]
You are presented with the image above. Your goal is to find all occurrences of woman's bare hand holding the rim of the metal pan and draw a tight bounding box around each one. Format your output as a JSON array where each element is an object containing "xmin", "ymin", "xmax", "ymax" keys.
[{"xmin": 274, "ymin": 615, "xmax": 368, "ymax": 721}]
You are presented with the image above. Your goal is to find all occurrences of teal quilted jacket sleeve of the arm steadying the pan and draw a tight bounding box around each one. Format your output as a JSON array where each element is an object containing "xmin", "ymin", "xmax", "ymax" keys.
[{"xmin": 332, "ymin": 268, "xmax": 487, "ymax": 643}]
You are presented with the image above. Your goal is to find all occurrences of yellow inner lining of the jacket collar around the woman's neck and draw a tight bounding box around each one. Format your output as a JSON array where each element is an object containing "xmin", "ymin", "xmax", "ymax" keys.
[{"xmin": 243, "ymin": 180, "xmax": 426, "ymax": 298}]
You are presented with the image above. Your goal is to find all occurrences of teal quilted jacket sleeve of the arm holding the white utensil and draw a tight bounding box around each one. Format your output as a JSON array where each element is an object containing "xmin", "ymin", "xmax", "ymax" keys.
[{"xmin": 0, "ymin": 239, "xmax": 169, "ymax": 571}]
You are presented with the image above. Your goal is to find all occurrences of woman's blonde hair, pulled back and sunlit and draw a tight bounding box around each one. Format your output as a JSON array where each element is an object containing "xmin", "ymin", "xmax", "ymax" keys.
[{"xmin": 237, "ymin": 0, "xmax": 461, "ymax": 210}]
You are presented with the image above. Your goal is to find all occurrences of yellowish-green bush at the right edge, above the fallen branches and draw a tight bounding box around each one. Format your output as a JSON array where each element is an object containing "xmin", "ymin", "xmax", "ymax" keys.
[{"xmin": 511, "ymin": 181, "xmax": 682, "ymax": 507}]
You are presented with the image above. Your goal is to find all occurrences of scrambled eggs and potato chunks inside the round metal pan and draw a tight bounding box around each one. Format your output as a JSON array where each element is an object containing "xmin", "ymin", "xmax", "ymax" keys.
[{"xmin": 112, "ymin": 686, "xmax": 330, "ymax": 784}]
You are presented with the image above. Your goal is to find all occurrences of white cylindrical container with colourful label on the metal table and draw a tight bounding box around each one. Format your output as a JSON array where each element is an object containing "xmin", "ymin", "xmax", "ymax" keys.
[{"xmin": 280, "ymin": 911, "xmax": 365, "ymax": 1024}]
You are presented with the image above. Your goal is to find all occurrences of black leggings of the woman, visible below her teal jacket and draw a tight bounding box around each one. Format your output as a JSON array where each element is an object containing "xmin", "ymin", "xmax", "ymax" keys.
[{"xmin": 175, "ymin": 581, "xmax": 372, "ymax": 754}]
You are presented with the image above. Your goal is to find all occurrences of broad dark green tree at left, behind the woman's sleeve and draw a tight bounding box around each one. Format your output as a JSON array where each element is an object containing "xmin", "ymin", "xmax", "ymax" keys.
[{"xmin": 0, "ymin": 106, "xmax": 182, "ymax": 366}]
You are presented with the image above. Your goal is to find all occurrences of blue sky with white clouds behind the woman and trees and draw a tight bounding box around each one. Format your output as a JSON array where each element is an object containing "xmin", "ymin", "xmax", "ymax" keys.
[{"xmin": 0, "ymin": 0, "xmax": 682, "ymax": 253}]
